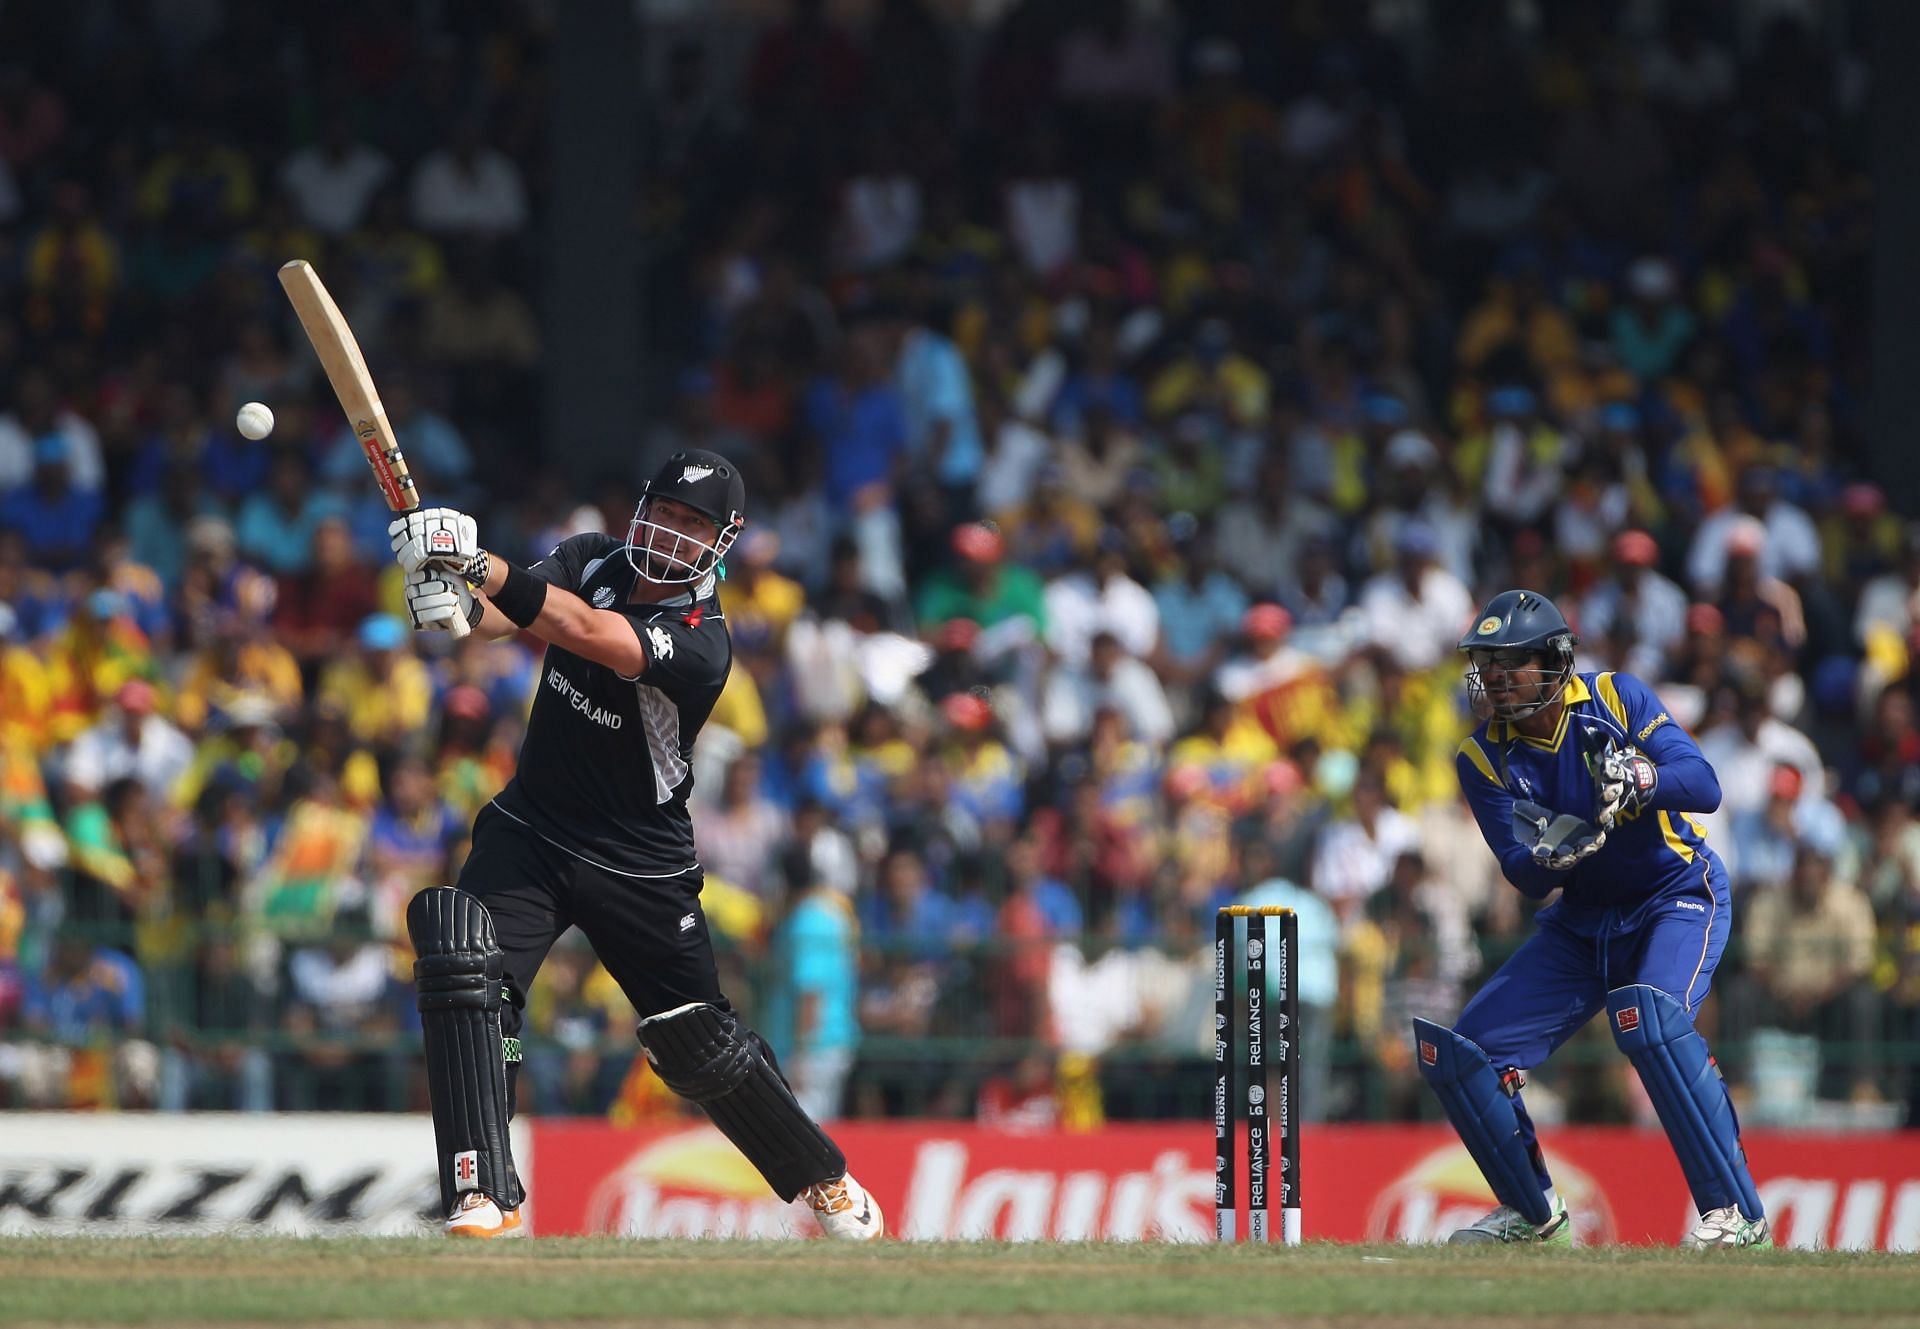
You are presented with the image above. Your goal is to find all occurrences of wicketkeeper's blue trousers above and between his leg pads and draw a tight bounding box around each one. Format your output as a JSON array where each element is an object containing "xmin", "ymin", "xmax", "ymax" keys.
[{"xmin": 1453, "ymin": 851, "xmax": 1734, "ymax": 1189}]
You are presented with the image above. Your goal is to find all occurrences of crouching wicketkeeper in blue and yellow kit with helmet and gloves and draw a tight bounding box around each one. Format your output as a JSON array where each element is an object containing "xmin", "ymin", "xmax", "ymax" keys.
[{"xmin": 1413, "ymin": 592, "xmax": 1772, "ymax": 1248}]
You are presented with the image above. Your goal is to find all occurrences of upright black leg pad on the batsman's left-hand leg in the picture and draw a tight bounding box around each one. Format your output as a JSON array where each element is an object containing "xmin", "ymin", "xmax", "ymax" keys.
[{"xmin": 407, "ymin": 885, "xmax": 526, "ymax": 1212}]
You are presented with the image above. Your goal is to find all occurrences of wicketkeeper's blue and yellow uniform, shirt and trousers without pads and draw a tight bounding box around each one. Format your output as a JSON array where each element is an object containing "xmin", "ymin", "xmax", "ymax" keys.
[{"xmin": 1455, "ymin": 674, "xmax": 1732, "ymax": 1075}]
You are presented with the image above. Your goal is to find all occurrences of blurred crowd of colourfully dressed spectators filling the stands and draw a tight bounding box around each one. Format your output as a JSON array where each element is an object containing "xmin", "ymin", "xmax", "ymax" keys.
[{"xmin": 0, "ymin": 0, "xmax": 1920, "ymax": 1124}]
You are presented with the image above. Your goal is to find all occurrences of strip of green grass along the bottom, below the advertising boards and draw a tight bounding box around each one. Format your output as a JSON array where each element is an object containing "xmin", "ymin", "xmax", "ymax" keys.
[{"xmin": 0, "ymin": 1239, "xmax": 1920, "ymax": 1329}]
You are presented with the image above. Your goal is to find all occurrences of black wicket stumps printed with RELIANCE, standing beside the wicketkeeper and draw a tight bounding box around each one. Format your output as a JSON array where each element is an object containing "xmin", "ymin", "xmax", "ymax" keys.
[{"xmin": 1213, "ymin": 905, "xmax": 1300, "ymax": 1246}]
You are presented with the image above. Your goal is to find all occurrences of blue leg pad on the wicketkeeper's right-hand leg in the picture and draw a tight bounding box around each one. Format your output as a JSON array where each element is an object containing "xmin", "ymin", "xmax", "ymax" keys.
[{"xmin": 1607, "ymin": 983, "xmax": 1763, "ymax": 1220}]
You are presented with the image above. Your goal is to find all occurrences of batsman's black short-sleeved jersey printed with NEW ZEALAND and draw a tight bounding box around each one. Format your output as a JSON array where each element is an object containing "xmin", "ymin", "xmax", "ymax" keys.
[{"xmin": 495, "ymin": 534, "xmax": 733, "ymax": 878}]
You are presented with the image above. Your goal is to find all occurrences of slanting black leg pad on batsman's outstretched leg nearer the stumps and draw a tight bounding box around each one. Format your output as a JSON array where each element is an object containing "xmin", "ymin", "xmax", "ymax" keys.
[{"xmin": 639, "ymin": 1003, "xmax": 847, "ymax": 1200}]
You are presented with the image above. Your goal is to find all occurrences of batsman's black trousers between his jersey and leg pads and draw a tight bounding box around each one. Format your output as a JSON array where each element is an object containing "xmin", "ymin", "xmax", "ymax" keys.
[{"xmin": 455, "ymin": 803, "xmax": 730, "ymax": 1037}]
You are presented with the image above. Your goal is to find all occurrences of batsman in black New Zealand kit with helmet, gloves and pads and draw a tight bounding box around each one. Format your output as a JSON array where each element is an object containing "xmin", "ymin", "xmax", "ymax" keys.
[{"xmin": 390, "ymin": 449, "xmax": 885, "ymax": 1241}]
